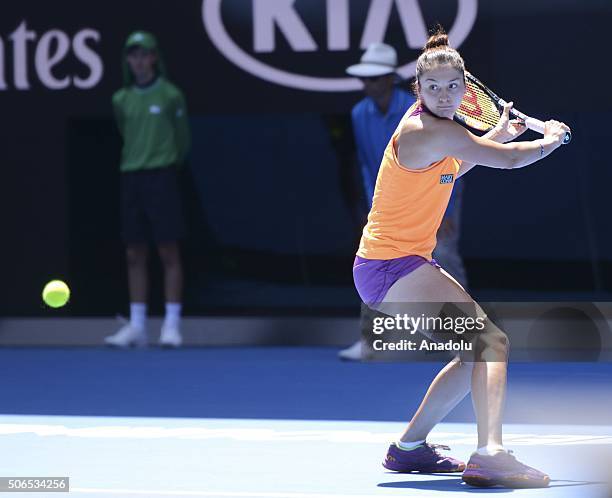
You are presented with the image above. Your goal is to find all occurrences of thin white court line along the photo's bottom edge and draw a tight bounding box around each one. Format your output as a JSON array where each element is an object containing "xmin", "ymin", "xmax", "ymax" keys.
[{"xmin": 70, "ymin": 486, "xmax": 416, "ymax": 498}]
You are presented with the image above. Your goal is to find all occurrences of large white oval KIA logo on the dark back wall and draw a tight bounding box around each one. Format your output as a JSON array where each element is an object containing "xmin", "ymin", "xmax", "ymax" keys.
[{"xmin": 202, "ymin": 0, "xmax": 478, "ymax": 92}]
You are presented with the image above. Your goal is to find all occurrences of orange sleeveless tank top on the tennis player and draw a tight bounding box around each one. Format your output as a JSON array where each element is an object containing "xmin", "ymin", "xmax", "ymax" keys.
[{"xmin": 357, "ymin": 105, "xmax": 461, "ymax": 260}]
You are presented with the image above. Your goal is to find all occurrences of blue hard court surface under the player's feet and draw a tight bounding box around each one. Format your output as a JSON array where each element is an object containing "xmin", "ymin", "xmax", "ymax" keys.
[{"xmin": 0, "ymin": 348, "xmax": 612, "ymax": 498}]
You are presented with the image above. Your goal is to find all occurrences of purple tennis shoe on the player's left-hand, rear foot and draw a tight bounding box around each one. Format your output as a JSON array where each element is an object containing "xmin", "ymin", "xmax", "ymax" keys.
[{"xmin": 383, "ymin": 443, "xmax": 465, "ymax": 474}]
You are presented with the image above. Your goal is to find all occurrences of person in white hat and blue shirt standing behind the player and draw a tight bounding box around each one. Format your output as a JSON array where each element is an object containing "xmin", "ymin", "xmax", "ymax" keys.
[{"xmin": 339, "ymin": 43, "xmax": 467, "ymax": 360}]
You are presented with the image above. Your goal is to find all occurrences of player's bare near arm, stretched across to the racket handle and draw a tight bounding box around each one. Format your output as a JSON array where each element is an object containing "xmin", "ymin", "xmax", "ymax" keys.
[{"xmin": 430, "ymin": 120, "xmax": 569, "ymax": 169}]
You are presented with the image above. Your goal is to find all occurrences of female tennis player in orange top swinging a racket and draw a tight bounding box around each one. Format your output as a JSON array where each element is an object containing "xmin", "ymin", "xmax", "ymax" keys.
[{"xmin": 353, "ymin": 29, "xmax": 569, "ymax": 487}]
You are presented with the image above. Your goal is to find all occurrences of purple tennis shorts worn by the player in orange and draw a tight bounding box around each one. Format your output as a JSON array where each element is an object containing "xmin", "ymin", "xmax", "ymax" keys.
[{"xmin": 353, "ymin": 255, "xmax": 439, "ymax": 306}]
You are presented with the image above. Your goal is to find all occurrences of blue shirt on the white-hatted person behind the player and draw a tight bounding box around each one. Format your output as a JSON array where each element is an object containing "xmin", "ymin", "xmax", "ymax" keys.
[{"xmin": 351, "ymin": 88, "xmax": 452, "ymax": 214}]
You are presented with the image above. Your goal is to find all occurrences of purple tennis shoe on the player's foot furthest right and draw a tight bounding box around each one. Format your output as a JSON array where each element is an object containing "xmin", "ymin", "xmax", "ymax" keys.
[{"xmin": 462, "ymin": 451, "xmax": 550, "ymax": 488}]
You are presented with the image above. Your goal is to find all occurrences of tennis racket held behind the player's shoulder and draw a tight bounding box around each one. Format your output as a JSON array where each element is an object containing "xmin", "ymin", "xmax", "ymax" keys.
[{"xmin": 455, "ymin": 71, "xmax": 572, "ymax": 144}]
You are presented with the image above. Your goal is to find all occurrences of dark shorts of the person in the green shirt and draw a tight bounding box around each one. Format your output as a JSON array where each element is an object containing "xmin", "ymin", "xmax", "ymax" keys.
[{"xmin": 121, "ymin": 167, "xmax": 185, "ymax": 244}]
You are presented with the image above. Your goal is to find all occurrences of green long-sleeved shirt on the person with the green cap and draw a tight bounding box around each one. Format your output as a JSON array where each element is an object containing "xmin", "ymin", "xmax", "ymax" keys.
[{"xmin": 113, "ymin": 76, "xmax": 191, "ymax": 172}]
